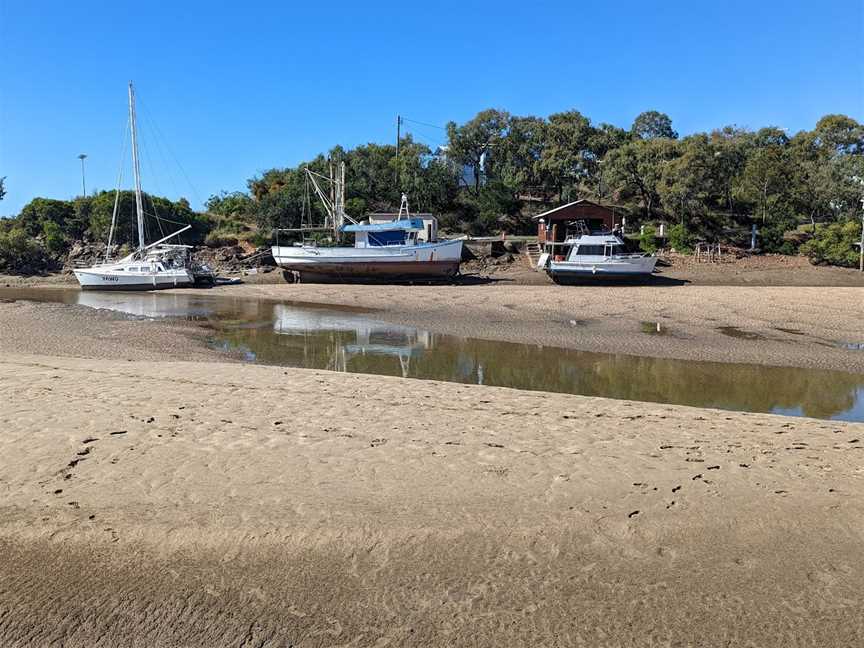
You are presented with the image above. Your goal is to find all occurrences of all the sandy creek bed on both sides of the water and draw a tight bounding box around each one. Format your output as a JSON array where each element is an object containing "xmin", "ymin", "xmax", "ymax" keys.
[{"xmin": 0, "ymin": 285, "xmax": 864, "ymax": 647}]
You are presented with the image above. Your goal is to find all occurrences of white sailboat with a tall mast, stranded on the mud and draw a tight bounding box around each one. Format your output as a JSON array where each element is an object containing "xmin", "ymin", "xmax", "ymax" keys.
[{"xmin": 74, "ymin": 82, "xmax": 195, "ymax": 290}]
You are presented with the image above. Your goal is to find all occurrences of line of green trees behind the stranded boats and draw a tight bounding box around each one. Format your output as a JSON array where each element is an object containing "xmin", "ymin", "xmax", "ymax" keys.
[{"xmin": 0, "ymin": 109, "xmax": 864, "ymax": 272}]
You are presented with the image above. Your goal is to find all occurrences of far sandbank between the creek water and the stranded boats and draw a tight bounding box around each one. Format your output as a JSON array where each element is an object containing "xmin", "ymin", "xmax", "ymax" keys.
[{"xmin": 182, "ymin": 284, "xmax": 864, "ymax": 373}]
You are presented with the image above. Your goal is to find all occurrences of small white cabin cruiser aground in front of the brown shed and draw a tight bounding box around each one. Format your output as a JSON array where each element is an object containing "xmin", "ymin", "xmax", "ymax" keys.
[{"xmin": 537, "ymin": 224, "xmax": 657, "ymax": 283}]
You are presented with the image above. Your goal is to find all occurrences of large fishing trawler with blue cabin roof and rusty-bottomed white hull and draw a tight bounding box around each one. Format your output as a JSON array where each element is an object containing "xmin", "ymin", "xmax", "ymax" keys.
[{"xmin": 272, "ymin": 162, "xmax": 462, "ymax": 281}]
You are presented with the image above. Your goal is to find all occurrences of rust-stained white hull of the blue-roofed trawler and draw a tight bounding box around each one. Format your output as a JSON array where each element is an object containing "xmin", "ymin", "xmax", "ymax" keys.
[{"xmin": 273, "ymin": 241, "xmax": 462, "ymax": 281}]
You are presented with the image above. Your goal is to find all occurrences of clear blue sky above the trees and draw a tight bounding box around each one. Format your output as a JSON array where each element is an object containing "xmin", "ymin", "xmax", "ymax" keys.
[{"xmin": 0, "ymin": 0, "xmax": 864, "ymax": 215}]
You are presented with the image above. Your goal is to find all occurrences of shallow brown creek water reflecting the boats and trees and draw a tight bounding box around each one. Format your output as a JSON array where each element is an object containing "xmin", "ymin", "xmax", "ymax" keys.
[{"xmin": 0, "ymin": 288, "xmax": 864, "ymax": 421}]
